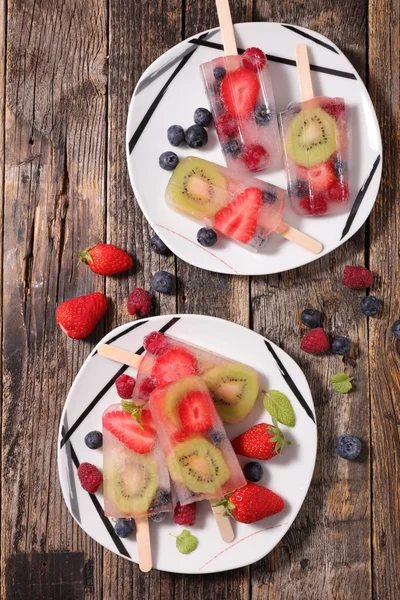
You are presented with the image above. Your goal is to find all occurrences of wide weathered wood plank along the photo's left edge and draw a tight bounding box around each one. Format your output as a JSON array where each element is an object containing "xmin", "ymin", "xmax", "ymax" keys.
[{"xmin": 1, "ymin": 0, "xmax": 107, "ymax": 599}]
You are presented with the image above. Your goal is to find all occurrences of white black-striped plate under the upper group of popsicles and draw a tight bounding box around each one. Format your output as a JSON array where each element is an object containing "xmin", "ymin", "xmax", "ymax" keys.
[{"xmin": 127, "ymin": 23, "xmax": 382, "ymax": 275}]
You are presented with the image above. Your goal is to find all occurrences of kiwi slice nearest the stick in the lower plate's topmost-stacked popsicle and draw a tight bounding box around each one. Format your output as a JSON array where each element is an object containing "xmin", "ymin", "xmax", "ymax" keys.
[{"xmin": 167, "ymin": 436, "xmax": 230, "ymax": 494}]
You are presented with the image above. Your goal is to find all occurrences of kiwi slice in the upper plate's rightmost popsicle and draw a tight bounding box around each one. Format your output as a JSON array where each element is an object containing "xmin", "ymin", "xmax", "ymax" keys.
[{"xmin": 285, "ymin": 108, "xmax": 338, "ymax": 167}]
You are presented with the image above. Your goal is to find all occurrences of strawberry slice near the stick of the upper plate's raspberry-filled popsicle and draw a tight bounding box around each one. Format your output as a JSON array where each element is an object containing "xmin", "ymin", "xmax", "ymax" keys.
[{"xmin": 221, "ymin": 69, "xmax": 260, "ymax": 119}]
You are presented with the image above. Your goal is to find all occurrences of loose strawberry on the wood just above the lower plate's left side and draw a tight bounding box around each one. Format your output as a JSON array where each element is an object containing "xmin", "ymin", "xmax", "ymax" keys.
[{"xmin": 56, "ymin": 292, "xmax": 107, "ymax": 340}]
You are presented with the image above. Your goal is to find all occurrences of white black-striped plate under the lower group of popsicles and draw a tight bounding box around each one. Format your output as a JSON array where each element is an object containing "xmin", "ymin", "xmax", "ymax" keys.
[{"xmin": 58, "ymin": 315, "xmax": 317, "ymax": 574}]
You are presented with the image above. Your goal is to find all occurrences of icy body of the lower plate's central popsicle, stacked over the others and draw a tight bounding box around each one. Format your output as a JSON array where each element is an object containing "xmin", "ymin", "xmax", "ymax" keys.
[{"xmin": 149, "ymin": 375, "xmax": 246, "ymax": 505}]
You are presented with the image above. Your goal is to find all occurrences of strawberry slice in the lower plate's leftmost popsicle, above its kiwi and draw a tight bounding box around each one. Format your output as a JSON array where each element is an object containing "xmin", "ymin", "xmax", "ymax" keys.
[{"xmin": 103, "ymin": 410, "xmax": 156, "ymax": 454}]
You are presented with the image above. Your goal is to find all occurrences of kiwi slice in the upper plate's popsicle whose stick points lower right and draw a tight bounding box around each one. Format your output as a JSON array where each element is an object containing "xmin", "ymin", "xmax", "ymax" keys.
[{"xmin": 166, "ymin": 157, "xmax": 227, "ymax": 220}]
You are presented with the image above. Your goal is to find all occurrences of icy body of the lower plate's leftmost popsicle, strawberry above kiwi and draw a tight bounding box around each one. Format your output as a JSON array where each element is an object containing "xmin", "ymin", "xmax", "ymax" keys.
[{"xmin": 103, "ymin": 404, "xmax": 172, "ymax": 518}]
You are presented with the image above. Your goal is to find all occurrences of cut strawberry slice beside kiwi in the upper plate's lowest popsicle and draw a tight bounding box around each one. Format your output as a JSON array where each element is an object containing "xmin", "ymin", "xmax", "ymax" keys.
[{"xmin": 213, "ymin": 188, "xmax": 262, "ymax": 244}]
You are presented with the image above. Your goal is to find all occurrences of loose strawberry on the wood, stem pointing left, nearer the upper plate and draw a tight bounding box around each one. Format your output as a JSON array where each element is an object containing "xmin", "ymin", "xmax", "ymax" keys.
[{"xmin": 79, "ymin": 244, "xmax": 133, "ymax": 275}]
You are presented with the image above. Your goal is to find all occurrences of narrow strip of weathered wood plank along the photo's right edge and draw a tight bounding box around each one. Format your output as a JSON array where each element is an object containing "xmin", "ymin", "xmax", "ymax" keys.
[{"xmin": 368, "ymin": 0, "xmax": 400, "ymax": 600}]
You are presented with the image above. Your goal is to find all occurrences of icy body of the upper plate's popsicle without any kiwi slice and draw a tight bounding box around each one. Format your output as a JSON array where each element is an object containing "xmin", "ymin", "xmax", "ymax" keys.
[{"xmin": 201, "ymin": 48, "xmax": 282, "ymax": 171}]
